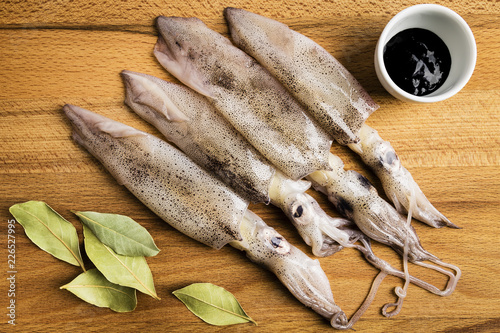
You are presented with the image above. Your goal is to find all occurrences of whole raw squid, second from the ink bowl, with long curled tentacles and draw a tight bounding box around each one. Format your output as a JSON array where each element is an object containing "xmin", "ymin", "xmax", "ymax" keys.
[{"xmin": 154, "ymin": 13, "xmax": 461, "ymax": 314}]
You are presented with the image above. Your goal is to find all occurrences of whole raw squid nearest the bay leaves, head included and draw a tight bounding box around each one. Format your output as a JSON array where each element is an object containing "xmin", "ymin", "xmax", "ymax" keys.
[{"xmin": 64, "ymin": 105, "xmax": 348, "ymax": 329}]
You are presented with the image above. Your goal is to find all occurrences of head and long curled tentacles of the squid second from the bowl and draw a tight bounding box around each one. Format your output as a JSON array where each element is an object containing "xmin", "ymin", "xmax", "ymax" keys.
[{"xmin": 308, "ymin": 155, "xmax": 461, "ymax": 301}]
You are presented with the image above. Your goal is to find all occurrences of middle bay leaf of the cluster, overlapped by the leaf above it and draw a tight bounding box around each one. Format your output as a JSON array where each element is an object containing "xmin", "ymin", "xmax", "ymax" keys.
[{"xmin": 83, "ymin": 224, "xmax": 160, "ymax": 299}]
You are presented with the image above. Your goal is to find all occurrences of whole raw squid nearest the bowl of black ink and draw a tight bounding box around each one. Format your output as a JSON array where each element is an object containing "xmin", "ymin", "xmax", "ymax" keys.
[{"xmin": 224, "ymin": 8, "xmax": 456, "ymax": 228}]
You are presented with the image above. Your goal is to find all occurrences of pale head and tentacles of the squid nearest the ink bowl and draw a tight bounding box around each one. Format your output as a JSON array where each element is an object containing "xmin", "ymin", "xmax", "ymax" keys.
[{"xmin": 349, "ymin": 124, "xmax": 458, "ymax": 228}]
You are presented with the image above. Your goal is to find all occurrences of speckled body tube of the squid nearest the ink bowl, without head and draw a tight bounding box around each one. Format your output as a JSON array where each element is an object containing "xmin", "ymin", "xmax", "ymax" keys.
[{"xmin": 224, "ymin": 8, "xmax": 378, "ymax": 145}]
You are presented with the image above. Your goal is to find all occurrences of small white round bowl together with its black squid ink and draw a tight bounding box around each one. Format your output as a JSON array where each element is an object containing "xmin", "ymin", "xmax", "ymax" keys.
[{"xmin": 374, "ymin": 4, "xmax": 477, "ymax": 103}]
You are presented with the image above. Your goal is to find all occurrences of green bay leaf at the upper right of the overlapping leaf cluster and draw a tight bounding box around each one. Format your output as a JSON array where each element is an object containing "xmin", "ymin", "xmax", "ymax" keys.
[{"xmin": 74, "ymin": 212, "xmax": 160, "ymax": 257}]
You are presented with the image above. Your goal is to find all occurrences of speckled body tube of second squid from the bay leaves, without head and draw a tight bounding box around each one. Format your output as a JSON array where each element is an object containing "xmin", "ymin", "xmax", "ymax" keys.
[{"xmin": 122, "ymin": 71, "xmax": 275, "ymax": 203}]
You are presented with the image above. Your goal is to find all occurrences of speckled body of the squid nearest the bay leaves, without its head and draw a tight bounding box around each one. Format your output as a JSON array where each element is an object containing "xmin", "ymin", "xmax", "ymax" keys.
[{"xmin": 64, "ymin": 105, "xmax": 248, "ymax": 249}]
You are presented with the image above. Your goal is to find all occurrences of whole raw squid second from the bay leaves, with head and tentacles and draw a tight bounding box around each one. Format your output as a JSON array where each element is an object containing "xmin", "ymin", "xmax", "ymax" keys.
[{"xmin": 122, "ymin": 71, "xmax": 458, "ymax": 300}]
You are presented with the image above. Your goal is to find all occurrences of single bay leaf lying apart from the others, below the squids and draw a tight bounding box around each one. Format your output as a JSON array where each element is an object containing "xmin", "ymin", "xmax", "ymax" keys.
[{"xmin": 173, "ymin": 283, "xmax": 257, "ymax": 326}]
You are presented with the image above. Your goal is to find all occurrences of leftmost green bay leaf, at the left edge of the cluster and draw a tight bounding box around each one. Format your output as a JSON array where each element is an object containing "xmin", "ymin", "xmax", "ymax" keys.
[{"xmin": 9, "ymin": 201, "xmax": 85, "ymax": 271}]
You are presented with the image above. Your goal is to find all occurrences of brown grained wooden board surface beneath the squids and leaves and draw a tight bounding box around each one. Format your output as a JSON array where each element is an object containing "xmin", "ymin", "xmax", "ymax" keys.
[{"xmin": 0, "ymin": 0, "xmax": 500, "ymax": 332}]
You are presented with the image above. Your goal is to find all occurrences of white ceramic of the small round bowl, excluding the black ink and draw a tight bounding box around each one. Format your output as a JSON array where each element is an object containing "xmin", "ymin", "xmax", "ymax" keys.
[{"xmin": 375, "ymin": 4, "xmax": 477, "ymax": 103}]
